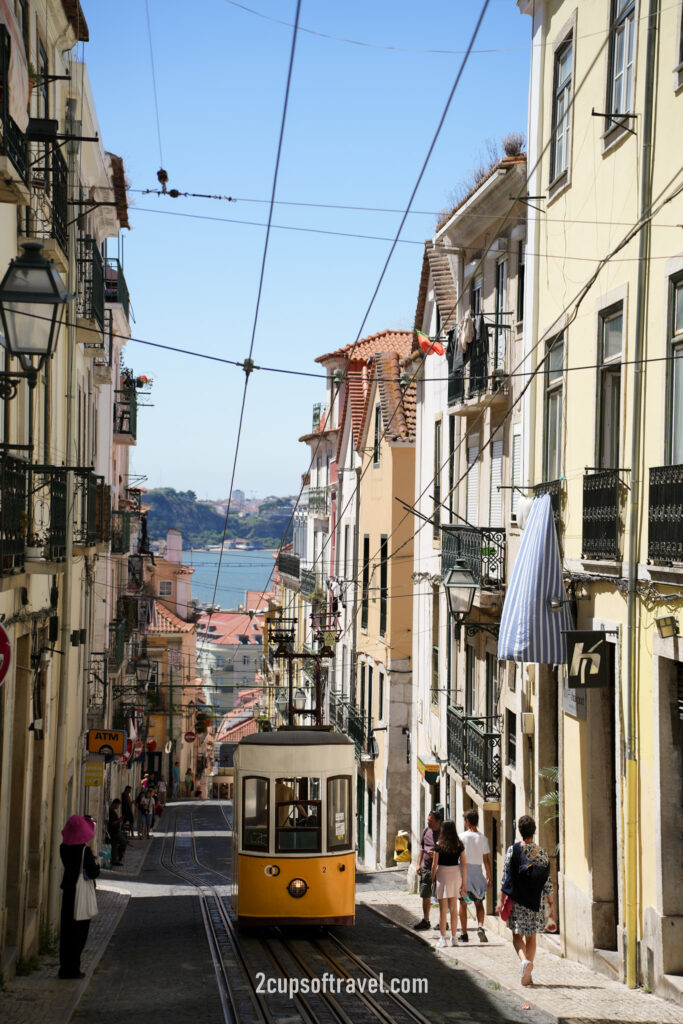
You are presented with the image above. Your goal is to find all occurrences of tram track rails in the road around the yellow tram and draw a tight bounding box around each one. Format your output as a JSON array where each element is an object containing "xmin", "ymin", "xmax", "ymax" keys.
[{"xmin": 162, "ymin": 806, "xmax": 430, "ymax": 1024}]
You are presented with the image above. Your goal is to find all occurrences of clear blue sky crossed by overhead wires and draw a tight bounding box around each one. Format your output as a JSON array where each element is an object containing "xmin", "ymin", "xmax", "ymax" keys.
[{"xmin": 83, "ymin": 0, "xmax": 530, "ymax": 498}]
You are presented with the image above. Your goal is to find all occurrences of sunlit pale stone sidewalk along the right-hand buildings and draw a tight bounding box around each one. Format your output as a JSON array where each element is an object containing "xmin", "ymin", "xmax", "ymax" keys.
[{"xmin": 356, "ymin": 890, "xmax": 683, "ymax": 1024}]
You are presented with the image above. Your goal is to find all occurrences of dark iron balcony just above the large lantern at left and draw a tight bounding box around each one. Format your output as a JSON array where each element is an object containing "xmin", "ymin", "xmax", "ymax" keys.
[{"xmin": 19, "ymin": 141, "xmax": 69, "ymax": 271}]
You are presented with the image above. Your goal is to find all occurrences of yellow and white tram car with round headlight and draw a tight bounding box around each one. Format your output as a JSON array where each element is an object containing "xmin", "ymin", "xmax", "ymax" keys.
[{"xmin": 232, "ymin": 727, "xmax": 355, "ymax": 926}]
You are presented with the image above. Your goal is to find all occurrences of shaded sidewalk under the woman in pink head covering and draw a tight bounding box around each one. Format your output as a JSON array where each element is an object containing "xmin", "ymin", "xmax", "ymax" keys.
[{"xmin": 0, "ymin": 840, "xmax": 153, "ymax": 1024}]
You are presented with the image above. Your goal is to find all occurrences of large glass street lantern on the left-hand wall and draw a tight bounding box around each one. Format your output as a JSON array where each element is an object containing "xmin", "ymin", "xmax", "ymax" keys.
[{"xmin": 0, "ymin": 242, "xmax": 73, "ymax": 387}]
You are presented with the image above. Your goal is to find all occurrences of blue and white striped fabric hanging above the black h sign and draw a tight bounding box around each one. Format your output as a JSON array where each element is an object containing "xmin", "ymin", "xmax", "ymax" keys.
[{"xmin": 498, "ymin": 495, "xmax": 573, "ymax": 665}]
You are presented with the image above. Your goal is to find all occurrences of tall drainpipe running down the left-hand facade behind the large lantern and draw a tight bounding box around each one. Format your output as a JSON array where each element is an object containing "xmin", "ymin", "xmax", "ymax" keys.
[{"xmin": 46, "ymin": 99, "xmax": 81, "ymax": 924}]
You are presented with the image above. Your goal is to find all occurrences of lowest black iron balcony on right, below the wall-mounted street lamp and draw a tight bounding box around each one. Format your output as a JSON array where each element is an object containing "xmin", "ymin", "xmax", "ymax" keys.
[{"xmin": 446, "ymin": 705, "xmax": 501, "ymax": 803}]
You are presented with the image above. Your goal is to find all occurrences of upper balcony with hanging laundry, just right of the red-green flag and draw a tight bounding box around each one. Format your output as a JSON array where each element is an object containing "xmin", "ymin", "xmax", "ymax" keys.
[{"xmin": 449, "ymin": 313, "xmax": 511, "ymax": 416}]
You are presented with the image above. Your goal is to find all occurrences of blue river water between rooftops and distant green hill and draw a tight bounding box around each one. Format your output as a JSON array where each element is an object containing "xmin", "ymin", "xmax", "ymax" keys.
[{"xmin": 182, "ymin": 548, "xmax": 274, "ymax": 609}]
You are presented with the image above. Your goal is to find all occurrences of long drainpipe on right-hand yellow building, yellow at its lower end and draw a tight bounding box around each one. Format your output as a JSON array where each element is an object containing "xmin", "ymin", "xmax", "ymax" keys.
[{"xmin": 624, "ymin": 0, "xmax": 659, "ymax": 988}]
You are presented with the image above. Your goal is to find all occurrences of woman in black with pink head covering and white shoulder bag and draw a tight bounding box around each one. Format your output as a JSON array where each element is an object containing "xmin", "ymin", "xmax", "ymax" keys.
[{"xmin": 58, "ymin": 814, "xmax": 99, "ymax": 978}]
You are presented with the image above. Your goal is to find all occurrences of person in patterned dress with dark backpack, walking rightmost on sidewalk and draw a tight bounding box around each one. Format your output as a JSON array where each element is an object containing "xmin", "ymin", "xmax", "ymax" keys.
[{"xmin": 497, "ymin": 814, "xmax": 555, "ymax": 985}]
